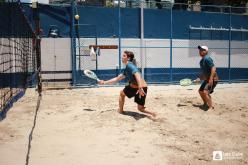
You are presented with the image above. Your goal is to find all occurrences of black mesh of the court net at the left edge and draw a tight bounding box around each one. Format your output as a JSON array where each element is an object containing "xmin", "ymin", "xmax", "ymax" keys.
[{"xmin": 0, "ymin": 3, "xmax": 36, "ymax": 114}]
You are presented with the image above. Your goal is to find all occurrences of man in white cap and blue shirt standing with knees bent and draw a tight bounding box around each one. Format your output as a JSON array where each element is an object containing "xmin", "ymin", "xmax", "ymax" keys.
[{"xmin": 195, "ymin": 46, "xmax": 218, "ymax": 110}]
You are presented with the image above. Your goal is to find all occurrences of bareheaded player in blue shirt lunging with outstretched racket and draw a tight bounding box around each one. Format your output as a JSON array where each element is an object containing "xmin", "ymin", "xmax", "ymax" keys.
[{"xmin": 99, "ymin": 51, "xmax": 156, "ymax": 117}]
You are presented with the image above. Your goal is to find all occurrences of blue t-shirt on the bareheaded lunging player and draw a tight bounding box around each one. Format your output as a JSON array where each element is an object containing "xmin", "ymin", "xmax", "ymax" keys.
[{"xmin": 122, "ymin": 61, "xmax": 139, "ymax": 84}]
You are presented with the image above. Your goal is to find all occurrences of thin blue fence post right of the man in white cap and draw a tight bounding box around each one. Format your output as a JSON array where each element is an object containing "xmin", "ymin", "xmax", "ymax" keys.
[{"xmin": 228, "ymin": 6, "xmax": 232, "ymax": 83}]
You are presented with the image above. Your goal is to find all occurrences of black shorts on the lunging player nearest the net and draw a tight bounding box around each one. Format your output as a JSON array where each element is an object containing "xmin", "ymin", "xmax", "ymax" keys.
[{"xmin": 123, "ymin": 85, "xmax": 147, "ymax": 106}]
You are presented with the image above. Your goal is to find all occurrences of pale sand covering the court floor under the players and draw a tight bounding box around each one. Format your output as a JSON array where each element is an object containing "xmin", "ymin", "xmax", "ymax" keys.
[{"xmin": 0, "ymin": 83, "xmax": 248, "ymax": 165}]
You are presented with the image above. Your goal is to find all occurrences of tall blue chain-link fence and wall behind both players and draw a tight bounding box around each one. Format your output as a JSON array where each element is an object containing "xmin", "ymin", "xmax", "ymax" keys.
[{"xmin": 19, "ymin": 2, "xmax": 248, "ymax": 85}]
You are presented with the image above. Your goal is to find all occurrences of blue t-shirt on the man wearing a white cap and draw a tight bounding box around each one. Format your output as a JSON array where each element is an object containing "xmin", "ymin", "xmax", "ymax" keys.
[{"xmin": 200, "ymin": 55, "xmax": 214, "ymax": 79}]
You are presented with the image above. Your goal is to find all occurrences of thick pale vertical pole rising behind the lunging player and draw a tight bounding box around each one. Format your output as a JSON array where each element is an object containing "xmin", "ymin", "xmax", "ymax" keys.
[{"xmin": 140, "ymin": 1, "xmax": 145, "ymax": 78}]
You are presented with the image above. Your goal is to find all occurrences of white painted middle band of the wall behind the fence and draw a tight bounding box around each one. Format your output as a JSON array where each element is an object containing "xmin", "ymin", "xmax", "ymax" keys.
[{"xmin": 41, "ymin": 38, "xmax": 248, "ymax": 78}]
